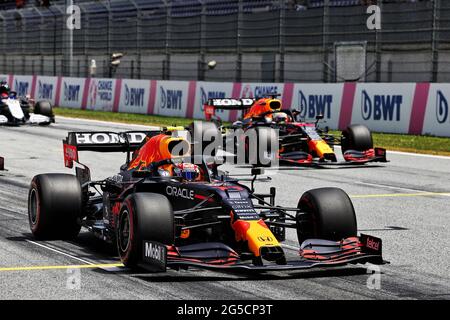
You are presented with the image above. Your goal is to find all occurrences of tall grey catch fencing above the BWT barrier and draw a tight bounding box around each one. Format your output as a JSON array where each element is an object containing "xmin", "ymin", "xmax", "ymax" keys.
[{"xmin": 0, "ymin": 0, "xmax": 450, "ymax": 83}]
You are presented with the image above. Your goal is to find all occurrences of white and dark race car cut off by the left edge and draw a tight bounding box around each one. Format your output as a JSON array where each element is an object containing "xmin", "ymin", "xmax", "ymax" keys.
[{"xmin": 0, "ymin": 83, "xmax": 55, "ymax": 126}]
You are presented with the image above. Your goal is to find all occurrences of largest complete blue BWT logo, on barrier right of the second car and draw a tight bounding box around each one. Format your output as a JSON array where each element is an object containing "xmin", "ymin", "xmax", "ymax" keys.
[{"xmin": 361, "ymin": 90, "xmax": 403, "ymax": 121}]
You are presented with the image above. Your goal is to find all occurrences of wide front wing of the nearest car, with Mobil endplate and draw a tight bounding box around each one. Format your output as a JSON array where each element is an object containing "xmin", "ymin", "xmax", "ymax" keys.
[{"xmin": 141, "ymin": 234, "xmax": 386, "ymax": 272}]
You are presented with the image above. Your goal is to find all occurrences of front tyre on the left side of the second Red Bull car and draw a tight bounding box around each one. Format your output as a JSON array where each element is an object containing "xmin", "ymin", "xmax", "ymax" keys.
[{"xmin": 245, "ymin": 127, "xmax": 279, "ymax": 167}]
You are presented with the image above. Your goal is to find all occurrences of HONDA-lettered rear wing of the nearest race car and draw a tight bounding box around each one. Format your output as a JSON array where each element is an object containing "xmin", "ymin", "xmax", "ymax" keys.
[{"xmin": 63, "ymin": 130, "xmax": 161, "ymax": 168}]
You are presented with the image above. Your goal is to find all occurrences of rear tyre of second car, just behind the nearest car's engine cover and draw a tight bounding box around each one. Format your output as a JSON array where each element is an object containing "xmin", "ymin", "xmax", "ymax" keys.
[{"xmin": 188, "ymin": 121, "xmax": 223, "ymax": 156}]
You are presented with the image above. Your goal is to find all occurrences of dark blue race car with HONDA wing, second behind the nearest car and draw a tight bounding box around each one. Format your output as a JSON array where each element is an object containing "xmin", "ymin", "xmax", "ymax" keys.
[{"xmin": 204, "ymin": 96, "xmax": 387, "ymax": 166}]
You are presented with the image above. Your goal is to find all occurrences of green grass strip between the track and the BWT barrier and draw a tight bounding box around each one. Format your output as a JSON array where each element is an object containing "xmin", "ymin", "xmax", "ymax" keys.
[{"xmin": 54, "ymin": 108, "xmax": 450, "ymax": 156}]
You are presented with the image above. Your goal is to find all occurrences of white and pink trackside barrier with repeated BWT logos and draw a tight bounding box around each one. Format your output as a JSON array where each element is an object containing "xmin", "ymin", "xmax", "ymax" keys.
[{"xmin": 0, "ymin": 74, "xmax": 450, "ymax": 137}]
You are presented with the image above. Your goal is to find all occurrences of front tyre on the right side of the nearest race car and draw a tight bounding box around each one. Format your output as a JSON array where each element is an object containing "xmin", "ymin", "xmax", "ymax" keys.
[{"xmin": 296, "ymin": 188, "xmax": 357, "ymax": 245}]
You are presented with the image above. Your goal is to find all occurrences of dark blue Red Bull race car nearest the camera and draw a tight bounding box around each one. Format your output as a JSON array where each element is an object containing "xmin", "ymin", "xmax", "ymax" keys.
[{"xmin": 28, "ymin": 126, "xmax": 384, "ymax": 271}]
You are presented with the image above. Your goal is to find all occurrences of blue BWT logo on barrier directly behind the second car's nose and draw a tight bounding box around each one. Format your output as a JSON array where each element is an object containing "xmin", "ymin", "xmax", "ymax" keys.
[{"xmin": 298, "ymin": 90, "xmax": 333, "ymax": 119}]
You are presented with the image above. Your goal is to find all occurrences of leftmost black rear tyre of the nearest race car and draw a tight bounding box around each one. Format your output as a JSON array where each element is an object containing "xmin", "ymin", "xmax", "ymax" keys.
[{"xmin": 28, "ymin": 173, "xmax": 82, "ymax": 240}]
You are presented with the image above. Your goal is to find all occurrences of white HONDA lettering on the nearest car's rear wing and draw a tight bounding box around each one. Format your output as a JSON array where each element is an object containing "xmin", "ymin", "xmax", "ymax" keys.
[{"xmin": 75, "ymin": 132, "xmax": 147, "ymax": 145}]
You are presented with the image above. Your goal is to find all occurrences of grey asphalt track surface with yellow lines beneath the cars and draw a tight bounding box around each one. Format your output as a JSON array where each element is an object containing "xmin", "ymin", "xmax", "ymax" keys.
[{"xmin": 0, "ymin": 118, "xmax": 450, "ymax": 300}]
